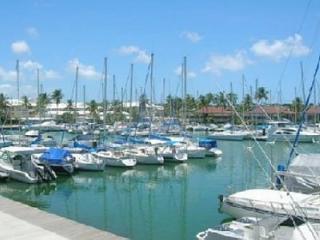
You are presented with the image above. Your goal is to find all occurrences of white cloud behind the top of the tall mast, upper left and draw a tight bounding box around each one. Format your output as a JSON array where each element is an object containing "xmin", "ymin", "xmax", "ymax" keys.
[{"xmin": 67, "ymin": 58, "xmax": 101, "ymax": 80}]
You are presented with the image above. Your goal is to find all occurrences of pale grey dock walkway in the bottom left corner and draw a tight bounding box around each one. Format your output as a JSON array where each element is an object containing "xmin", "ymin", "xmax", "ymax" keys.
[{"xmin": 0, "ymin": 196, "xmax": 125, "ymax": 240}]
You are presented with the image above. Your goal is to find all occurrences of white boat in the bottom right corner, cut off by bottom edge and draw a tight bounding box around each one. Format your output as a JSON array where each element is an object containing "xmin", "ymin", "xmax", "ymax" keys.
[{"xmin": 196, "ymin": 216, "xmax": 320, "ymax": 240}]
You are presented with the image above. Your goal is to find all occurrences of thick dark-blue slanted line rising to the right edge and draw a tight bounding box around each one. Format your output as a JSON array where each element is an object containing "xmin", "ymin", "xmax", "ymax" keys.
[{"xmin": 287, "ymin": 55, "xmax": 320, "ymax": 166}]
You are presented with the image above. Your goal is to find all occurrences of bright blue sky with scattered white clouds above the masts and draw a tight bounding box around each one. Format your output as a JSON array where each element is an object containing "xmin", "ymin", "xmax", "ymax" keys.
[{"xmin": 0, "ymin": 0, "xmax": 320, "ymax": 102}]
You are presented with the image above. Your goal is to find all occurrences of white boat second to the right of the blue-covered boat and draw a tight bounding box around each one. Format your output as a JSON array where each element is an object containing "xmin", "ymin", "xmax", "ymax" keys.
[{"xmin": 92, "ymin": 150, "xmax": 137, "ymax": 167}]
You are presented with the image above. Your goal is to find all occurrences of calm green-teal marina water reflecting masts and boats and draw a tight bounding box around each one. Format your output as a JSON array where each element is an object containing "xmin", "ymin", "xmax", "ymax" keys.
[{"xmin": 0, "ymin": 135, "xmax": 320, "ymax": 239}]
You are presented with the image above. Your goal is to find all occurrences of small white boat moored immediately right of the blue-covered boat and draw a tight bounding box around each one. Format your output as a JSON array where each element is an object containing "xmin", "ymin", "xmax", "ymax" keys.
[{"xmin": 72, "ymin": 153, "xmax": 106, "ymax": 171}]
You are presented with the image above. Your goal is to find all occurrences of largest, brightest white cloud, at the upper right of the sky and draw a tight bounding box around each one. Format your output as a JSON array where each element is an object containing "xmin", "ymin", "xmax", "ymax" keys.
[{"xmin": 251, "ymin": 34, "xmax": 311, "ymax": 61}]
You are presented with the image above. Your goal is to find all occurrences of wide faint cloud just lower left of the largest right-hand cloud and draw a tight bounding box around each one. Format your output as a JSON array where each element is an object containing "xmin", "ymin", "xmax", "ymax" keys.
[{"xmin": 202, "ymin": 50, "xmax": 253, "ymax": 75}]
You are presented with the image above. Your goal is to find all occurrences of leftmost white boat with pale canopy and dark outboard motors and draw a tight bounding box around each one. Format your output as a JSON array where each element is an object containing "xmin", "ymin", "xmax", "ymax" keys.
[{"xmin": 0, "ymin": 146, "xmax": 57, "ymax": 183}]
